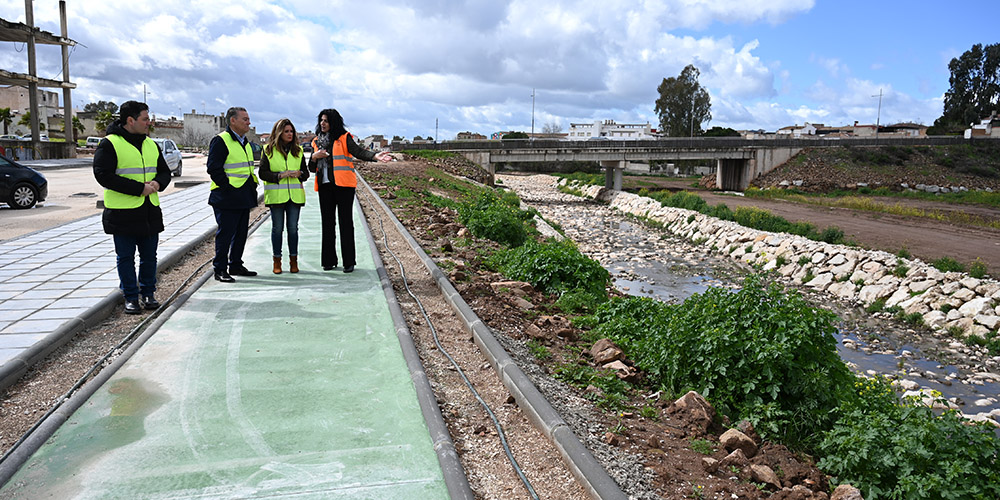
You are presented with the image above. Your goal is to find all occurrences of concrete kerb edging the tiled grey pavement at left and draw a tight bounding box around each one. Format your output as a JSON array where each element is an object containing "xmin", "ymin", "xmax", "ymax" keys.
[{"xmin": 0, "ymin": 221, "xmax": 215, "ymax": 391}]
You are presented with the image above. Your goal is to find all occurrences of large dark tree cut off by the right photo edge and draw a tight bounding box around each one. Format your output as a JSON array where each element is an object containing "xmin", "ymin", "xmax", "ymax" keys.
[{"xmin": 934, "ymin": 43, "xmax": 1000, "ymax": 130}]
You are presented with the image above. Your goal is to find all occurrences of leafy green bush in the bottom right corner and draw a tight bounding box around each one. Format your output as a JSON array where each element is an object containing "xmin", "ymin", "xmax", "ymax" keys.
[{"xmin": 818, "ymin": 379, "xmax": 1000, "ymax": 499}]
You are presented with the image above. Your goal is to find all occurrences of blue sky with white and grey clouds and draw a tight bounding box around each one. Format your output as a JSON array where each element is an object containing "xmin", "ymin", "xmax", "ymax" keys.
[{"xmin": 0, "ymin": 0, "xmax": 1000, "ymax": 140}]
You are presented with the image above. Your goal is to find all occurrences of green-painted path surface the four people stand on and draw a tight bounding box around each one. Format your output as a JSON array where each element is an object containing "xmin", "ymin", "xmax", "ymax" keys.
[{"xmin": 0, "ymin": 190, "xmax": 448, "ymax": 500}]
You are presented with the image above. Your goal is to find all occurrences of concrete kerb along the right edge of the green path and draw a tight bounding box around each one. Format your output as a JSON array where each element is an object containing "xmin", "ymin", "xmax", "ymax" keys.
[{"xmin": 355, "ymin": 201, "xmax": 475, "ymax": 500}]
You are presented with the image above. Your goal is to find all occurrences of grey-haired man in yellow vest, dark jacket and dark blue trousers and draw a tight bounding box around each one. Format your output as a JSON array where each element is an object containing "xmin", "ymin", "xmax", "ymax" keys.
[{"xmin": 205, "ymin": 107, "xmax": 257, "ymax": 283}]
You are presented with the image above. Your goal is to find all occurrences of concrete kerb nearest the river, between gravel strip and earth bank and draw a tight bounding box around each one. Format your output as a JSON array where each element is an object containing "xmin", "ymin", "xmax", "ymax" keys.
[{"xmin": 361, "ymin": 179, "xmax": 628, "ymax": 500}]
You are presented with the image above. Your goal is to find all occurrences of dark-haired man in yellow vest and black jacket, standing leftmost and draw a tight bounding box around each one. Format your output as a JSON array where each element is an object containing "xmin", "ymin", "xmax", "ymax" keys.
[{"xmin": 94, "ymin": 101, "xmax": 170, "ymax": 314}]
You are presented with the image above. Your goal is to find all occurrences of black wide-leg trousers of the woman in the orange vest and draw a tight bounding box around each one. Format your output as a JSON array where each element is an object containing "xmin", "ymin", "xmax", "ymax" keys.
[{"xmin": 319, "ymin": 182, "xmax": 357, "ymax": 267}]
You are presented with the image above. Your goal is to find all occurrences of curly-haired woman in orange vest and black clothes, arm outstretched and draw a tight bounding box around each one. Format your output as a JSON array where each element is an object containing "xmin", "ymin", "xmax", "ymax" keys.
[{"xmin": 309, "ymin": 109, "xmax": 392, "ymax": 273}]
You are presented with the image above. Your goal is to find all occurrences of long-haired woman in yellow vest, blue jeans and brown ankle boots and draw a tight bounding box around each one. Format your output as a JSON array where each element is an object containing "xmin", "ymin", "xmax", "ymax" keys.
[{"xmin": 257, "ymin": 118, "xmax": 309, "ymax": 274}]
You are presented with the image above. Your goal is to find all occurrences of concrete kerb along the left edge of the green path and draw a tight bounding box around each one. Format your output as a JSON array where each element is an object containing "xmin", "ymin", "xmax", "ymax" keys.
[{"xmin": 0, "ymin": 272, "xmax": 212, "ymax": 487}]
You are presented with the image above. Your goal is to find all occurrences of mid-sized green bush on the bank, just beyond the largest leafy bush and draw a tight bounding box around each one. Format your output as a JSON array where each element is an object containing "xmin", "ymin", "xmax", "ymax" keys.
[{"xmin": 490, "ymin": 240, "xmax": 610, "ymax": 297}]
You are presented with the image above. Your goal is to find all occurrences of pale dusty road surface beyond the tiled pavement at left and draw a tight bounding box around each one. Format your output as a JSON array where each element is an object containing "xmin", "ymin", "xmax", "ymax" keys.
[{"xmin": 0, "ymin": 155, "xmax": 209, "ymax": 241}]
